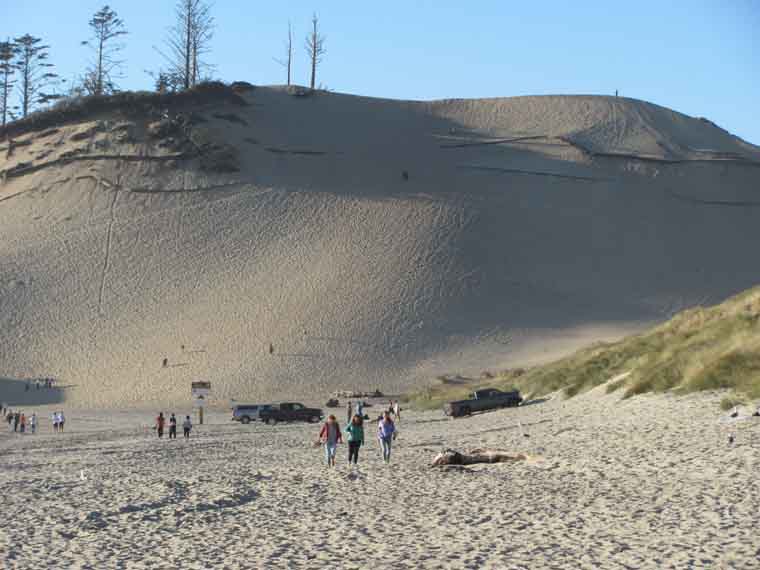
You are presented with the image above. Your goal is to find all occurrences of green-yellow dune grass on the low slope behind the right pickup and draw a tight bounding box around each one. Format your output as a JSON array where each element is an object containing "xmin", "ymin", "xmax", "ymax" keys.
[{"xmin": 409, "ymin": 287, "xmax": 760, "ymax": 408}]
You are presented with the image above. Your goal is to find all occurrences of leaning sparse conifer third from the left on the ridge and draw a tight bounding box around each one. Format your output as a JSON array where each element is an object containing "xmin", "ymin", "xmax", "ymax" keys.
[{"xmin": 82, "ymin": 6, "xmax": 127, "ymax": 95}]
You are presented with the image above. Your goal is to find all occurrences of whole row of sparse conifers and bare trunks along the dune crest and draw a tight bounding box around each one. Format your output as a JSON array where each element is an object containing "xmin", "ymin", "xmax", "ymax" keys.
[{"xmin": 0, "ymin": 0, "xmax": 326, "ymax": 126}]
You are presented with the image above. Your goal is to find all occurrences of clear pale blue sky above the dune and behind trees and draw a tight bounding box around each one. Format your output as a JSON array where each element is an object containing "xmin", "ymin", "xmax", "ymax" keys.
[{"xmin": 0, "ymin": 0, "xmax": 760, "ymax": 144}]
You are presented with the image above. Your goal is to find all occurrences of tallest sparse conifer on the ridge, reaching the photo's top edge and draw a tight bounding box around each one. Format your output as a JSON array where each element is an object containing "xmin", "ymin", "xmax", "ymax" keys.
[{"xmin": 158, "ymin": 0, "xmax": 214, "ymax": 89}]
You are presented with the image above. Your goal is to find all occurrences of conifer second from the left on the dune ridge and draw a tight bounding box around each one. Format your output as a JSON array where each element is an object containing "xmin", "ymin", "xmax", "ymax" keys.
[{"xmin": 14, "ymin": 34, "xmax": 59, "ymax": 117}]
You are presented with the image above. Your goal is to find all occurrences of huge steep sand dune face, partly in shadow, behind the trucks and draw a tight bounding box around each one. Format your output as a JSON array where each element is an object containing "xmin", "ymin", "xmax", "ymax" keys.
[{"xmin": 0, "ymin": 88, "xmax": 760, "ymax": 407}]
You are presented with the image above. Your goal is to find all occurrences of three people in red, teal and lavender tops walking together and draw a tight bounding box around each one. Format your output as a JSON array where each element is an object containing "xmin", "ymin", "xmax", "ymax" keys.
[{"xmin": 317, "ymin": 411, "xmax": 398, "ymax": 467}]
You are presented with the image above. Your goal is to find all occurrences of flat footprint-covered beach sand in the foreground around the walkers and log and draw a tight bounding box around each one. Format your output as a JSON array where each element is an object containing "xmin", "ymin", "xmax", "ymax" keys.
[{"xmin": 0, "ymin": 388, "xmax": 760, "ymax": 570}]
